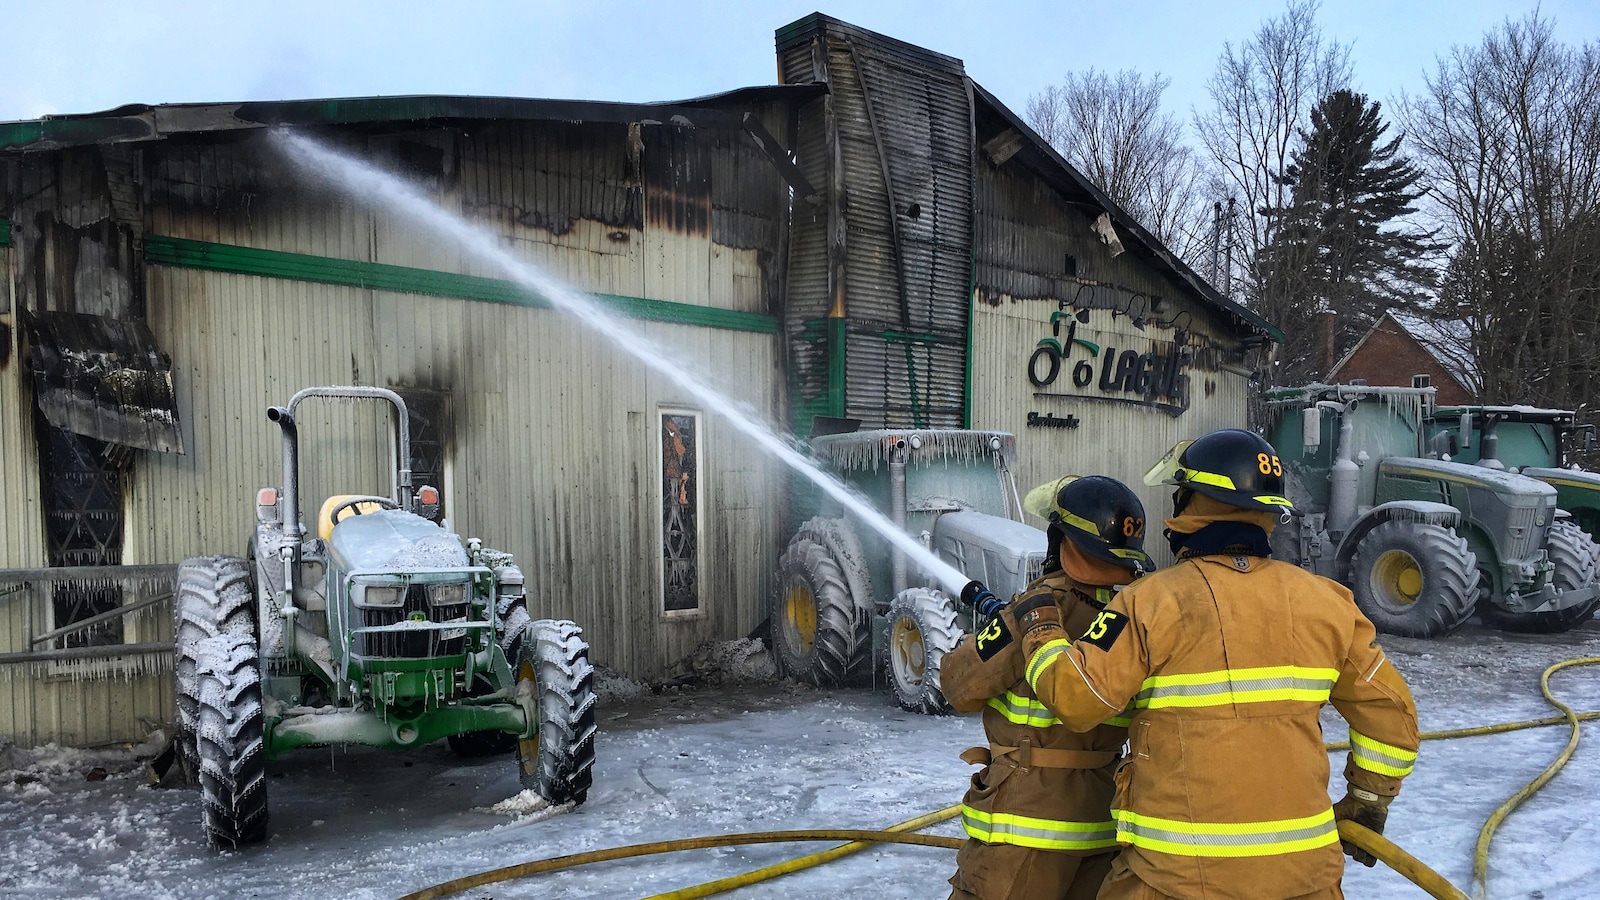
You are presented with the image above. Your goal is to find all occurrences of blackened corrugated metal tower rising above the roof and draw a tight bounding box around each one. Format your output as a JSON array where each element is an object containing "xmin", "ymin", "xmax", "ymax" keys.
[{"xmin": 779, "ymin": 16, "xmax": 973, "ymax": 428}]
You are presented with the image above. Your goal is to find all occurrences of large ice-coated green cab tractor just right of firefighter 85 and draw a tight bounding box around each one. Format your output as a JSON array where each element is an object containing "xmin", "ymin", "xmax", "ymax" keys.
[{"xmin": 1266, "ymin": 384, "xmax": 1600, "ymax": 637}]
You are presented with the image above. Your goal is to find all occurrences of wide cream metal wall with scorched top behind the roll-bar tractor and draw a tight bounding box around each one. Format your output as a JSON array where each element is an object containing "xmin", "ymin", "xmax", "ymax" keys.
[{"xmin": 0, "ymin": 101, "xmax": 792, "ymax": 740}]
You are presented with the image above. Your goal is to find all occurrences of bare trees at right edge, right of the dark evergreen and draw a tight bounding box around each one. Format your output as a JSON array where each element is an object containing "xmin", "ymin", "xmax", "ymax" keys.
[{"xmin": 1403, "ymin": 13, "xmax": 1600, "ymax": 405}]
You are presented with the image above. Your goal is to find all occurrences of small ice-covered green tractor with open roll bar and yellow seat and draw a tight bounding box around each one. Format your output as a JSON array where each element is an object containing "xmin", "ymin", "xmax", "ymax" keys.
[{"xmin": 174, "ymin": 388, "xmax": 595, "ymax": 849}]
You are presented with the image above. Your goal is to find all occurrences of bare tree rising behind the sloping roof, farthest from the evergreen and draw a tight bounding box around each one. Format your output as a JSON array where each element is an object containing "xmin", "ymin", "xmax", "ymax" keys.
[{"xmin": 1027, "ymin": 69, "xmax": 1205, "ymax": 259}]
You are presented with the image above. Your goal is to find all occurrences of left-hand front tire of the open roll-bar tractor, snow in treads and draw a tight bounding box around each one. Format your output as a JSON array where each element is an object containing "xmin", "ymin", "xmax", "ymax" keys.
[{"xmin": 195, "ymin": 633, "xmax": 267, "ymax": 850}]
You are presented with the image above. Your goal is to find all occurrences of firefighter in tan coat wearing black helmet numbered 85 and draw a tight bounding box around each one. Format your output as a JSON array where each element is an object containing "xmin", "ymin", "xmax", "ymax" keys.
[{"xmin": 1013, "ymin": 429, "xmax": 1418, "ymax": 900}]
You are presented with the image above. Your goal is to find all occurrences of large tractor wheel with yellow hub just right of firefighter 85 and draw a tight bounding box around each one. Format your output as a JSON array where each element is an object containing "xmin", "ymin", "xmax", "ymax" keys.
[{"xmin": 1350, "ymin": 520, "xmax": 1480, "ymax": 637}]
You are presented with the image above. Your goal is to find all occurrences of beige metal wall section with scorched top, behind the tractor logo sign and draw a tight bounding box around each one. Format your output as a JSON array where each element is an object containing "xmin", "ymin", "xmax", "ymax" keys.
[{"xmin": 971, "ymin": 152, "xmax": 1250, "ymax": 562}]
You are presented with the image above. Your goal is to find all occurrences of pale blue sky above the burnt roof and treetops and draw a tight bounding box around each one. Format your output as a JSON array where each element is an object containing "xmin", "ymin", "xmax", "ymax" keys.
[{"xmin": 0, "ymin": 0, "xmax": 1600, "ymax": 128}]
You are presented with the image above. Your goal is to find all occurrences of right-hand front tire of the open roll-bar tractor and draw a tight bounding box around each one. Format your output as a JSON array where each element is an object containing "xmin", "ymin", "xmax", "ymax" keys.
[{"xmin": 515, "ymin": 618, "xmax": 595, "ymax": 806}]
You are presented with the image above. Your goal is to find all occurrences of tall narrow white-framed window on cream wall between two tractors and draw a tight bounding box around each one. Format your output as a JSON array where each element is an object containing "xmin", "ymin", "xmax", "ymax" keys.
[{"xmin": 661, "ymin": 410, "xmax": 701, "ymax": 613}]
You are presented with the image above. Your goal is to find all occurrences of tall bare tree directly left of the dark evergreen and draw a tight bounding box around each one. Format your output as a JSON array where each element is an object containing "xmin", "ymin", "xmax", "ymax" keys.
[{"xmin": 1195, "ymin": 0, "xmax": 1350, "ymax": 301}]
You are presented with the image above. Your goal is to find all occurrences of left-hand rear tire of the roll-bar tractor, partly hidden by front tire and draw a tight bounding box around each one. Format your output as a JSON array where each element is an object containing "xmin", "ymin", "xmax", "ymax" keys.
[{"xmin": 173, "ymin": 556, "xmax": 256, "ymax": 781}]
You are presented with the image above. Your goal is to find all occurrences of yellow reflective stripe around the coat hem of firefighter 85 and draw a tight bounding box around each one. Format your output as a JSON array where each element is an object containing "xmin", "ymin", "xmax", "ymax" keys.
[{"xmin": 1110, "ymin": 809, "xmax": 1339, "ymax": 857}]
